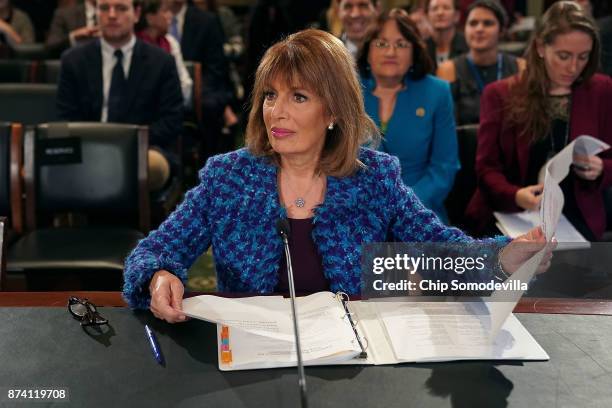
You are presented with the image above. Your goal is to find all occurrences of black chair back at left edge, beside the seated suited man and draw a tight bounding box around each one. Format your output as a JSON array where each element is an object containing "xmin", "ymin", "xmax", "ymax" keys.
[{"xmin": 0, "ymin": 84, "xmax": 57, "ymax": 125}]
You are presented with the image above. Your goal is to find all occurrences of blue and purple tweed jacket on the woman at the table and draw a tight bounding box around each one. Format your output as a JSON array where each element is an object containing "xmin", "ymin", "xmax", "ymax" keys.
[{"xmin": 123, "ymin": 148, "xmax": 507, "ymax": 308}]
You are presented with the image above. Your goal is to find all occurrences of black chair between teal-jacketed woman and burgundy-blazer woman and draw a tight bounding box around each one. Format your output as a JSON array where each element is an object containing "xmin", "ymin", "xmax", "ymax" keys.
[{"xmin": 444, "ymin": 124, "xmax": 478, "ymax": 227}]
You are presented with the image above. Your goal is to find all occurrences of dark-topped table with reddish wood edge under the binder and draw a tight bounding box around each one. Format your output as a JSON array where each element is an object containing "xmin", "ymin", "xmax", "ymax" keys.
[{"xmin": 0, "ymin": 292, "xmax": 612, "ymax": 408}]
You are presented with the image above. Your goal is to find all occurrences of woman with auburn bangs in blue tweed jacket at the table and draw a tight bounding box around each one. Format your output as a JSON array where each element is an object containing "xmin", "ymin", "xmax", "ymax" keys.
[{"xmin": 124, "ymin": 30, "xmax": 542, "ymax": 322}]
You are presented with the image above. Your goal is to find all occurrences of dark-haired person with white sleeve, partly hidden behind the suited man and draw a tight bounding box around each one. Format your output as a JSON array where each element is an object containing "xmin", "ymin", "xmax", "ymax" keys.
[{"xmin": 136, "ymin": 0, "xmax": 193, "ymax": 107}]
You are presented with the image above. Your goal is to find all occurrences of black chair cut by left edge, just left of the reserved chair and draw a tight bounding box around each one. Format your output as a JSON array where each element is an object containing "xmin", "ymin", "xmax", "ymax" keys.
[{"xmin": 0, "ymin": 122, "xmax": 23, "ymax": 241}]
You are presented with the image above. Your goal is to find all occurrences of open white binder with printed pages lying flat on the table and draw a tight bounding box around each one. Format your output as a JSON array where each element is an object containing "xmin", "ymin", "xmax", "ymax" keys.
[{"xmin": 183, "ymin": 292, "xmax": 548, "ymax": 370}]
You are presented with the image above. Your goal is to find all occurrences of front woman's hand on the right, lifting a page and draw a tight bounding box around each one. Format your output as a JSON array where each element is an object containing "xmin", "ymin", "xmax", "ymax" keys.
[{"xmin": 500, "ymin": 227, "xmax": 557, "ymax": 275}]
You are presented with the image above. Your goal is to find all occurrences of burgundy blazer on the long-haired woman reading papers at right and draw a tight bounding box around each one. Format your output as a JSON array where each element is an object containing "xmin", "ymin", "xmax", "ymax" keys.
[{"xmin": 466, "ymin": 74, "xmax": 612, "ymax": 239}]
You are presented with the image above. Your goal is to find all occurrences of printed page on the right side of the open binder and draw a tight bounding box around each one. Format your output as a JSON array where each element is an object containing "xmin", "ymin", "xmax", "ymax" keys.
[{"xmin": 376, "ymin": 302, "xmax": 548, "ymax": 362}]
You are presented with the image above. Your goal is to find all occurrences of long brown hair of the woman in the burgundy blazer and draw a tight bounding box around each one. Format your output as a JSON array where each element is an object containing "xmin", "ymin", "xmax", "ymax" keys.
[{"xmin": 506, "ymin": 1, "xmax": 600, "ymax": 139}]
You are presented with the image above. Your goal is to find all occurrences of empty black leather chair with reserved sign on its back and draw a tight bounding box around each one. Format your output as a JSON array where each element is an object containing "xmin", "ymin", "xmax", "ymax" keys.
[{"xmin": 7, "ymin": 123, "xmax": 149, "ymax": 290}]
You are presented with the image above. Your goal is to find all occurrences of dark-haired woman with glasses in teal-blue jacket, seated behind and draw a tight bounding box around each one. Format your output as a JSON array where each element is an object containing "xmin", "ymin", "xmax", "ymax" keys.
[{"xmin": 359, "ymin": 9, "xmax": 459, "ymax": 222}]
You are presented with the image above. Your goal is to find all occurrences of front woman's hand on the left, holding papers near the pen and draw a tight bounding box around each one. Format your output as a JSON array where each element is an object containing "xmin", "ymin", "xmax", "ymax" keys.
[{"xmin": 149, "ymin": 270, "xmax": 187, "ymax": 323}]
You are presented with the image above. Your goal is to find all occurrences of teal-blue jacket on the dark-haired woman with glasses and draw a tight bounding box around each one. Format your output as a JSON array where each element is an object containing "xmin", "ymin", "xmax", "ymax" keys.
[{"xmin": 362, "ymin": 75, "xmax": 459, "ymax": 222}]
